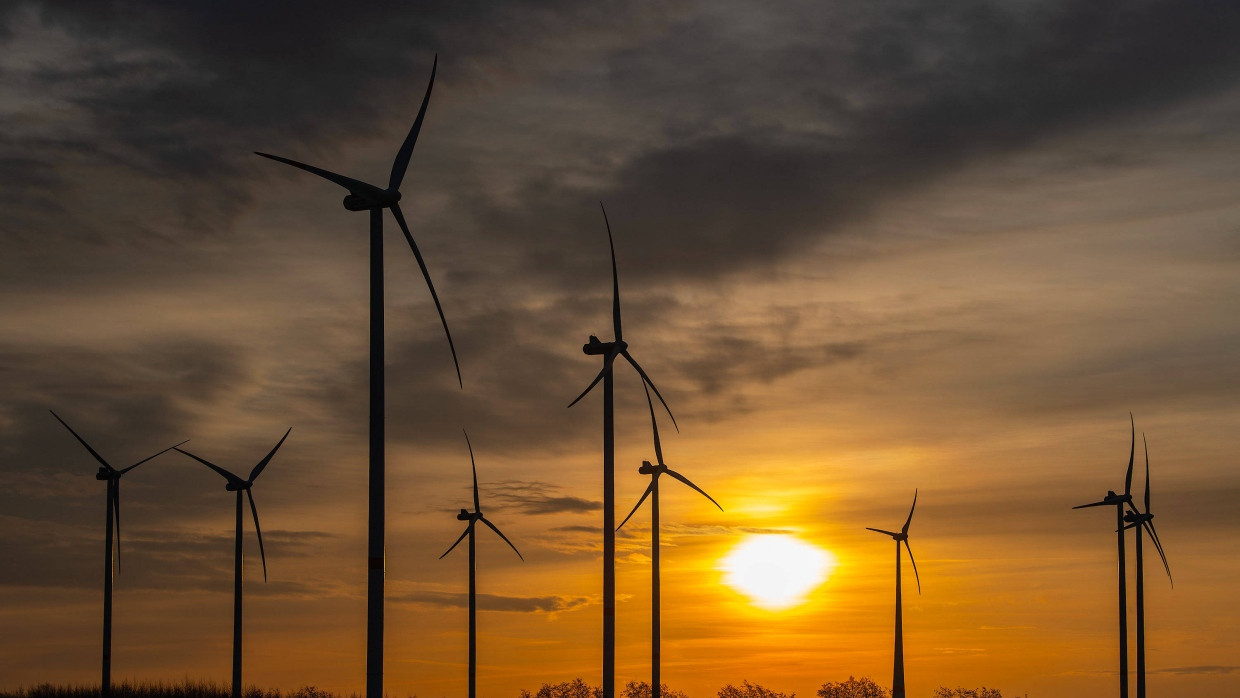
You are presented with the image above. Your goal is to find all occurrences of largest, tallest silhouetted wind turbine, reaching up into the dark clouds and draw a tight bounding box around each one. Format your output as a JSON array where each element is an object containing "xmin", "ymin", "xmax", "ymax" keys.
[{"xmin": 257, "ymin": 56, "xmax": 464, "ymax": 698}]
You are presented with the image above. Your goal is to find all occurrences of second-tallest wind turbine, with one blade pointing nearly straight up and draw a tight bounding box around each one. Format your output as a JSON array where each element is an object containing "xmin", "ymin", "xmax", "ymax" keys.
[{"xmin": 568, "ymin": 202, "xmax": 680, "ymax": 698}]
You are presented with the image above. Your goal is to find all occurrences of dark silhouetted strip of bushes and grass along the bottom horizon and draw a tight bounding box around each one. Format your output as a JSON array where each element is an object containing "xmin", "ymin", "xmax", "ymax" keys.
[{"xmin": 0, "ymin": 676, "xmax": 1003, "ymax": 698}]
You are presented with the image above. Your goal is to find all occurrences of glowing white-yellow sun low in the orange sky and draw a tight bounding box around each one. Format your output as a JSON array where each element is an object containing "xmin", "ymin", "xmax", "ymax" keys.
[{"xmin": 719, "ymin": 533, "xmax": 836, "ymax": 611}]
